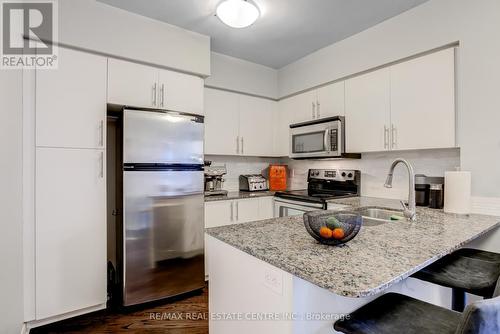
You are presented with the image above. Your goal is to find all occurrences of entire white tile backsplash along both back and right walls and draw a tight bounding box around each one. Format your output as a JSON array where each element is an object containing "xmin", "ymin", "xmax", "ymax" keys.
[{"xmin": 205, "ymin": 148, "xmax": 460, "ymax": 199}]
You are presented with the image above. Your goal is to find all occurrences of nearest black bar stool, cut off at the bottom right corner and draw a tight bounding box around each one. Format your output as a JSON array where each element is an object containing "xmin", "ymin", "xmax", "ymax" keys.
[{"xmin": 333, "ymin": 280, "xmax": 500, "ymax": 334}]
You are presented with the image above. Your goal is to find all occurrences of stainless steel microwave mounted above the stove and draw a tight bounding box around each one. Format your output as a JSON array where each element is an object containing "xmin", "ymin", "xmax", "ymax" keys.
[{"xmin": 290, "ymin": 116, "xmax": 360, "ymax": 159}]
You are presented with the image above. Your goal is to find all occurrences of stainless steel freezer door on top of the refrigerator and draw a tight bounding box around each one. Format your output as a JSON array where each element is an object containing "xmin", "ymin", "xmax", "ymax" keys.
[{"xmin": 123, "ymin": 109, "xmax": 204, "ymax": 165}]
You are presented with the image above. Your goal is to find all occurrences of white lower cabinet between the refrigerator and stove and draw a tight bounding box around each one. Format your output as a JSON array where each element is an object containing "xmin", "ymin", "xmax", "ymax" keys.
[{"xmin": 205, "ymin": 196, "xmax": 274, "ymax": 277}]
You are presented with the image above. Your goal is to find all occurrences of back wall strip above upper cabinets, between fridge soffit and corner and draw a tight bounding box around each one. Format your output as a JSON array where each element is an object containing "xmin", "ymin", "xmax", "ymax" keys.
[{"xmin": 205, "ymin": 52, "xmax": 278, "ymax": 98}]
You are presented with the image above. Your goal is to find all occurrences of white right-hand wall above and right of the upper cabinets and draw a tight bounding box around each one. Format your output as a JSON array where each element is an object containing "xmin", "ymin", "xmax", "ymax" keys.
[{"xmin": 278, "ymin": 0, "xmax": 500, "ymax": 197}]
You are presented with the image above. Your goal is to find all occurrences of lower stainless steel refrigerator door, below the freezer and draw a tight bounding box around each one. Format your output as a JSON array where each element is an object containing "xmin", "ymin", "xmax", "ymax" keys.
[{"xmin": 123, "ymin": 170, "xmax": 205, "ymax": 306}]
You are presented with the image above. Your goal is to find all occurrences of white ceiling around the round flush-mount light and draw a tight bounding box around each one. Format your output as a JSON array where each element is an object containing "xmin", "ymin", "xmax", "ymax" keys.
[{"xmin": 99, "ymin": 0, "xmax": 428, "ymax": 68}]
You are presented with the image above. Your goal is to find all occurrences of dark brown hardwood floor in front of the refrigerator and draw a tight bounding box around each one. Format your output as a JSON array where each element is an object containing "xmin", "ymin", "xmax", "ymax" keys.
[{"xmin": 30, "ymin": 284, "xmax": 208, "ymax": 334}]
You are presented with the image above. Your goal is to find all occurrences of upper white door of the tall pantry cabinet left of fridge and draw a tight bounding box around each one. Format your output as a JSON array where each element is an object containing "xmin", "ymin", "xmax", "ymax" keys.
[{"xmin": 36, "ymin": 48, "xmax": 107, "ymax": 148}]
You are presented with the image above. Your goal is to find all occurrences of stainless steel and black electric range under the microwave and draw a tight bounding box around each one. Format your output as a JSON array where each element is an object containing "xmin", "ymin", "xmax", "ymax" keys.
[{"xmin": 274, "ymin": 169, "xmax": 361, "ymax": 217}]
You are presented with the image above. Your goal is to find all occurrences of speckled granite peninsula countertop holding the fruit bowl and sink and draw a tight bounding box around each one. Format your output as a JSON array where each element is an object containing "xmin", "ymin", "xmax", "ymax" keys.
[{"xmin": 206, "ymin": 197, "xmax": 500, "ymax": 297}]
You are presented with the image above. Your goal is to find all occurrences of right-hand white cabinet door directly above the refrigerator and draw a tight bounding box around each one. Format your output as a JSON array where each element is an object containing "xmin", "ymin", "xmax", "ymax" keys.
[{"xmin": 158, "ymin": 70, "xmax": 203, "ymax": 115}]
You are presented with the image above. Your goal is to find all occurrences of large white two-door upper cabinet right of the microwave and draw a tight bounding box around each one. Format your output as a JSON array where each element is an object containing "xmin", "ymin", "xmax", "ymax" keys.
[{"xmin": 345, "ymin": 49, "xmax": 456, "ymax": 152}]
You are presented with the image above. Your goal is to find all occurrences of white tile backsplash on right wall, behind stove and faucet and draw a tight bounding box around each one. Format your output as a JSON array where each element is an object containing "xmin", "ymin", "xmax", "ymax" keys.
[{"xmin": 281, "ymin": 149, "xmax": 460, "ymax": 199}]
